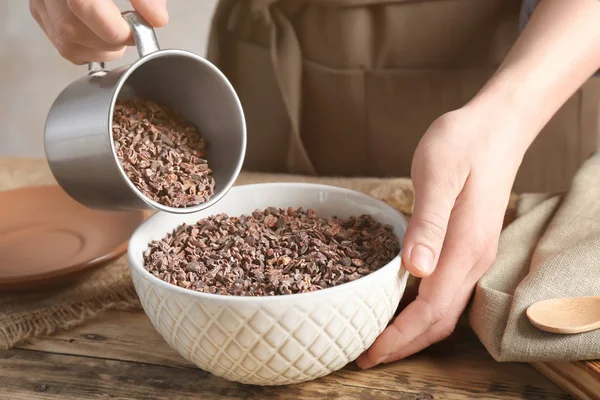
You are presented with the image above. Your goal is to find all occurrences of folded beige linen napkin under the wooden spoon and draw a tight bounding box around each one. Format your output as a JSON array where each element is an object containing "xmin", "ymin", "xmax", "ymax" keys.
[{"xmin": 470, "ymin": 154, "xmax": 600, "ymax": 362}]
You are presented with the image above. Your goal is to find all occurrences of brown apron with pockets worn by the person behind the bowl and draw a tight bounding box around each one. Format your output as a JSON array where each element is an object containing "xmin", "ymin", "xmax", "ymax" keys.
[{"xmin": 208, "ymin": 0, "xmax": 600, "ymax": 191}]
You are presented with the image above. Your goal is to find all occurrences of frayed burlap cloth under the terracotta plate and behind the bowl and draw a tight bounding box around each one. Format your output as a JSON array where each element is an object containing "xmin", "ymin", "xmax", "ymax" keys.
[{"xmin": 0, "ymin": 158, "xmax": 416, "ymax": 349}]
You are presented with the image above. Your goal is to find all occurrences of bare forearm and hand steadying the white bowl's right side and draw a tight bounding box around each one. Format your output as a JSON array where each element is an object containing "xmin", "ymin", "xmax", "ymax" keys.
[{"xmin": 357, "ymin": 0, "xmax": 600, "ymax": 368}]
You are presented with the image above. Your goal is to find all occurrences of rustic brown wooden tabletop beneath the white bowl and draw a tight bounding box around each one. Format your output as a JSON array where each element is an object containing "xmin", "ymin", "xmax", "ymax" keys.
[{"xmin": 0, "ymin": 311, "xmax": 571, "ymax": 400}]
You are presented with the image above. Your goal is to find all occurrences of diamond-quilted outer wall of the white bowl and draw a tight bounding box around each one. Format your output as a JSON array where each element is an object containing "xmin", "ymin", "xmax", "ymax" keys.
[{"xmin": 130, "ymin": 185, "xmax": 408, "ymax": 385}]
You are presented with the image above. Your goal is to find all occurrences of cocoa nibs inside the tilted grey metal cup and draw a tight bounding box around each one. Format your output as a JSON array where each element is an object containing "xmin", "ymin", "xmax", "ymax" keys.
[{"xmin": 112, "ymin": 100, "xmax": 215, "ymax": 208}]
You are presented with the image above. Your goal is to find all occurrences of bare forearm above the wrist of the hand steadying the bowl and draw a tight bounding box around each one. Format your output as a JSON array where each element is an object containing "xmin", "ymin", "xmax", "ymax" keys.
[{"xmin": 472, "ymin": 0, "xmax": 600, "ymax": 152}]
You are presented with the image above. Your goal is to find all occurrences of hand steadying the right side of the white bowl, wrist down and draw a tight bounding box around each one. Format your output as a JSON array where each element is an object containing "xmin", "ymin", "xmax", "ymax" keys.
[{"xmin": 357, "ymin": 104, "xmax": 529, "ymax": 368}]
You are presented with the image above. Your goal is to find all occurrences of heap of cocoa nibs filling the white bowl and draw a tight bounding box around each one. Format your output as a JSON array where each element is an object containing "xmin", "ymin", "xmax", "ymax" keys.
[{"xmin": 144, "ymin": 207, "xmax": 400, "ymax": 296}]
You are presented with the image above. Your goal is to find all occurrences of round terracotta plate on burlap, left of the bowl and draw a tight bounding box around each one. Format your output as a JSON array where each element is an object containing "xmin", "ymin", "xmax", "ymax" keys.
[{"xmin": 0, "ymin": 186, "xmax": 144, "ymax": 290}]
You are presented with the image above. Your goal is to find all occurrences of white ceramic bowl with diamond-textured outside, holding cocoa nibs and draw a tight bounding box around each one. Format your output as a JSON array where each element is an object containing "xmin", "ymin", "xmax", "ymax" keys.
[{"xmin": 129, "ymin": 183, "xmax": 408, "ymax": 385}]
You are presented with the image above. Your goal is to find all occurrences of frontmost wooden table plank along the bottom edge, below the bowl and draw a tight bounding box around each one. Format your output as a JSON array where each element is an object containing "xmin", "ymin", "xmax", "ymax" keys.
[{"xmin": 0, "ymin": 349, "xmax": 418, "ymax": 400}]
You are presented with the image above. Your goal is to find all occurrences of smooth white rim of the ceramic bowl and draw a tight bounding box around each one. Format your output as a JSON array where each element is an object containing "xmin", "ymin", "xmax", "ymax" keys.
[{"xmin": 127, "ymin": 182, "xmax": 408, "ymax": 303}]
